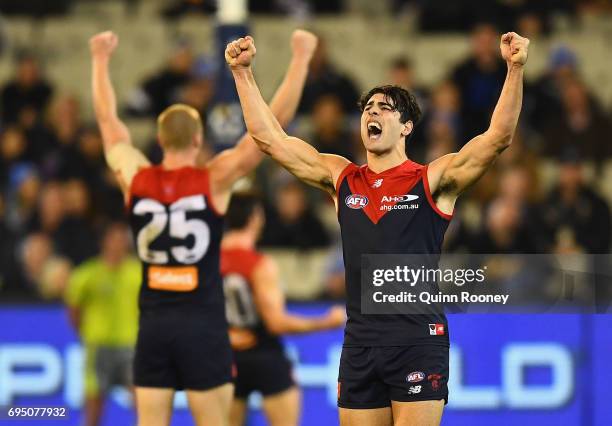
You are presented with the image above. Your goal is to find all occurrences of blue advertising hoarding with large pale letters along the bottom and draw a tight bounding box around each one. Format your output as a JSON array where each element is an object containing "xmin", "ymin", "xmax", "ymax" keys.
[{"xmin": 0, "ymin": 304, "xmax": 612, "ymax": 426}]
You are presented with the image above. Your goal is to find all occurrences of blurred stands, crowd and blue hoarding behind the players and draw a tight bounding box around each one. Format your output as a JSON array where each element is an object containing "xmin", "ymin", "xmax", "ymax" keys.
[{"xmin": 0, "ymin": 0, "xmax": 612, "ymax": 426}]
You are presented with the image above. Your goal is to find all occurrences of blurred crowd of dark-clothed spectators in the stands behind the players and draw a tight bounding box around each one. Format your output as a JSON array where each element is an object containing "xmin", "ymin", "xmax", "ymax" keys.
[{"xmin": 0, "ymin": 10, "xmax": 612, "ymax": 300}]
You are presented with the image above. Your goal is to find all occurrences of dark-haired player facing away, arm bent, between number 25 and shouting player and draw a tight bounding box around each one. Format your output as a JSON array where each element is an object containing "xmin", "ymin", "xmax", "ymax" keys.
[{"xmin": 221, "ymin": 193, "xmax": 346, "ymax": 426}]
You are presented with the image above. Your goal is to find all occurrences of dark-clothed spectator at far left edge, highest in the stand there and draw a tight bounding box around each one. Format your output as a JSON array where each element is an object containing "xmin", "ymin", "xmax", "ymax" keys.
[{"xmin": 0, "ymin": 54, "xmax": 53, "ymax": 124}]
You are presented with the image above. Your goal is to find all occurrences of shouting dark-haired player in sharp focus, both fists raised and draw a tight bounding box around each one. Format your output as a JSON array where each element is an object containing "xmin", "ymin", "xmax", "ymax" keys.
[{"xmin": 225, "ymin": 33, "xmax": 529, "ymax": 426}]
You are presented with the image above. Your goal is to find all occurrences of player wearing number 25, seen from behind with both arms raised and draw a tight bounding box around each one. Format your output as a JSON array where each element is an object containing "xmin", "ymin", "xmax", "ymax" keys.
[{"xmin": 90, "ymin": 31, "xmax": 317, "ymax": 426}]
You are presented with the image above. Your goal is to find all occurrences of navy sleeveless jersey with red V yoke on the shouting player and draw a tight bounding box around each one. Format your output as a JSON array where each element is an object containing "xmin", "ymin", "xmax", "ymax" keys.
[{"xmin": 336, "ymin": 160, "xmax": 451, "ymax": 346}]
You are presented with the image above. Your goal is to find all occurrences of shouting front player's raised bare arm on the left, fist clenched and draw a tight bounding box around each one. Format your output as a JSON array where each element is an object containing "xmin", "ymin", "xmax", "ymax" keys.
[{"xmin": 226, "ymin": 38, "xmax": 349, "ymax": 195}]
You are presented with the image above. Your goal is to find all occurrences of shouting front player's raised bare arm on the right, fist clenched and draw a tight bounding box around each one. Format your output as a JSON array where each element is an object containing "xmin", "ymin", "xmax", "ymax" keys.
[{"xmin": 428, "ymin": 33, "xmax": 529, "ymax": 213}]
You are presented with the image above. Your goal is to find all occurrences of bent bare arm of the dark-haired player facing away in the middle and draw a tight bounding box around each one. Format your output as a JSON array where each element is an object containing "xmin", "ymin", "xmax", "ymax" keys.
[{"xmin": 252, "ymin": 257, "xmax": 344, "ymax": 334}]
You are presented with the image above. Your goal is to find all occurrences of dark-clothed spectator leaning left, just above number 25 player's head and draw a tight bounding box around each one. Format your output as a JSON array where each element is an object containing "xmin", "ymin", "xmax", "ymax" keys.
[{"xmin": 127, "ymin": 40, "xmax": 194, "ymax": 117}]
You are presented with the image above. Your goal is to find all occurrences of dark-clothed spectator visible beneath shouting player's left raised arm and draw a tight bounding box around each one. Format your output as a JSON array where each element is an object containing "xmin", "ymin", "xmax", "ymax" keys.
[{"xmin": 260, "ymin": 180, "xmax": 330, "ymax": 250}]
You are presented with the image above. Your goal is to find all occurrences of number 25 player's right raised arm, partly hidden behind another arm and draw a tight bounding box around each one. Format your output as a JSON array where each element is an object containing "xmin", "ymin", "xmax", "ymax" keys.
[{"xmin": 207, "ymin": 30, "xmax": 317, "ymax": 206}]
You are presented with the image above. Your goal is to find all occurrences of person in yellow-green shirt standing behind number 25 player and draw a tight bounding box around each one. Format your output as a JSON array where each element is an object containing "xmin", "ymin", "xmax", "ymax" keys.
[{"xmin": 65, "ymin": 222, "xmax": 141, "ymax": 426}]
